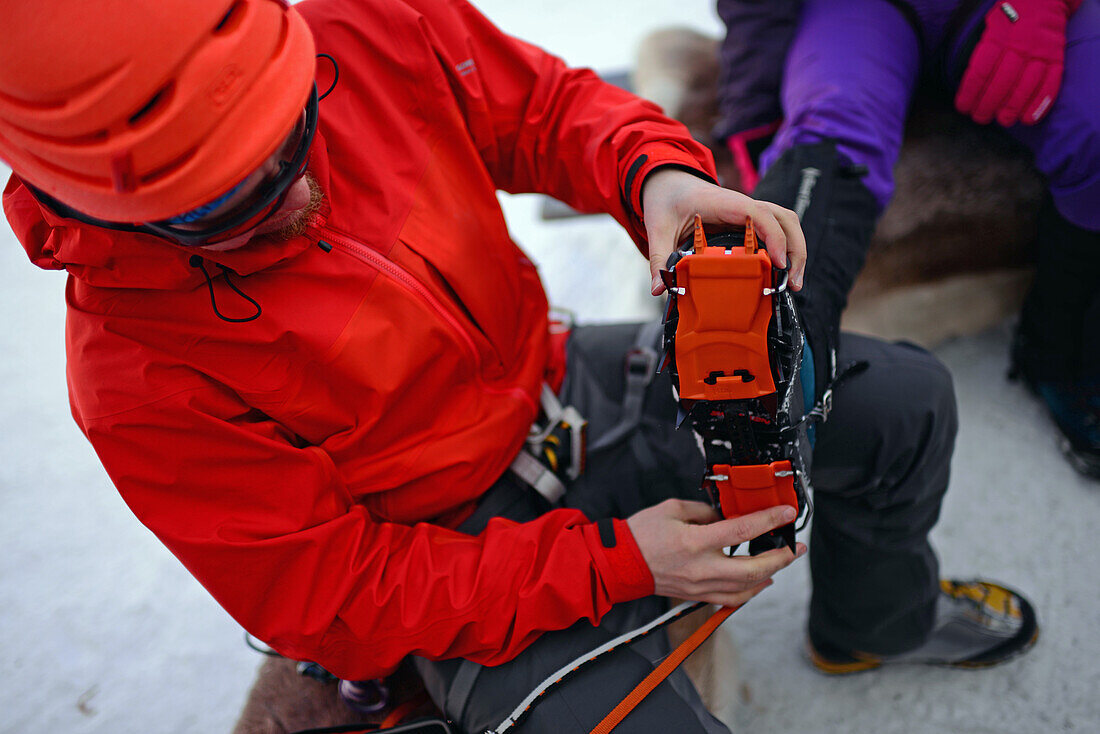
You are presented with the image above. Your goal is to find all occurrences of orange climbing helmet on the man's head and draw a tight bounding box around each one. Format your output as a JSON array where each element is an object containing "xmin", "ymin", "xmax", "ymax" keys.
[{"xmin": 0, "ymin": 0, "xmax": 315, "ymax": 222}]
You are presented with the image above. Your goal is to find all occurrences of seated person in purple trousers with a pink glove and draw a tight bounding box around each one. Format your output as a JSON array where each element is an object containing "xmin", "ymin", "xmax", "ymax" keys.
[{"xmin": 715, "ymin": 0, "xmax": 1100, "ymax": 490}]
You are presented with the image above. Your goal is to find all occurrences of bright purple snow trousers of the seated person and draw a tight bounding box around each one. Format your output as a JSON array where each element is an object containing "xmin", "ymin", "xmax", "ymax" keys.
[{"xmin": 760, "ymin": 0, "xmax": 1100, "ymax": 230}]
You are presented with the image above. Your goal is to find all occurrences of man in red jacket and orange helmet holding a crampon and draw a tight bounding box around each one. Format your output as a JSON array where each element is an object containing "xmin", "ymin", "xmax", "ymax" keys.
[{"xmin": 0, "ymin": 0, "xmax": 1035, "ymax": 732}]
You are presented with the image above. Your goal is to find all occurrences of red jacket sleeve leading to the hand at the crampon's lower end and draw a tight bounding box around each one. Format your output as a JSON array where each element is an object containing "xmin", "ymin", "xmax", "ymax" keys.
[{"xmin": 70, "ymin": 382, "xmax": 653, "ymax": 680}]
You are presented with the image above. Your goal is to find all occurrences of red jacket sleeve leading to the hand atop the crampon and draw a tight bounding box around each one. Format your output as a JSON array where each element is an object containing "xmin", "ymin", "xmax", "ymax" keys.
[{"xmin": 408, "ymin": 0, "xmax": 716, "ymax": 252}]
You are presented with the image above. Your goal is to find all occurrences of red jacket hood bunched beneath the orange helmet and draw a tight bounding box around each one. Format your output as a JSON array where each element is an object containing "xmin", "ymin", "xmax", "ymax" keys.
[{"xmin": 3, "ymin": 131, "xmax": 328, "ymax": 291}]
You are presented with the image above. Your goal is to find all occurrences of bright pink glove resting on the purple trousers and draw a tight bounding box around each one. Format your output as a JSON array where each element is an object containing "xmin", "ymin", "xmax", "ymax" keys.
[{"xmin": 955, "ymin": 0, "xmax": 1081, "ymax": 127}]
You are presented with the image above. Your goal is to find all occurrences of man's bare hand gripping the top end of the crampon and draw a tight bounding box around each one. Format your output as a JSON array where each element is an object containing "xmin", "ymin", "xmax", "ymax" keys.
[{"xmin": 641, "ymin": 168, "xmax": 806, "ymax": 296}]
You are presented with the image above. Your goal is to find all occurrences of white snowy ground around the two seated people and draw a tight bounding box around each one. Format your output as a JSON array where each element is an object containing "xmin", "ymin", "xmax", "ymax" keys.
[{"xmin": 0, "ymin": 0, "xmax": 1100, "ymax": 734}]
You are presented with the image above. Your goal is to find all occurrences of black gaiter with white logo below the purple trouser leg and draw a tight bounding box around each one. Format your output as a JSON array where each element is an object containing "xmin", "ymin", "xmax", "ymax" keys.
[{"xmin": 752, "ymin": 140, "xmax": 880, "ymax": 402}]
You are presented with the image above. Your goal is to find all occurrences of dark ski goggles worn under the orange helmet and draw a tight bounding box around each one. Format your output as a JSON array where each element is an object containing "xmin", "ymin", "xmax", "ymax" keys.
[{"xmin": 138, "ymin": 87, "xmax": 317, "ymax": 247}]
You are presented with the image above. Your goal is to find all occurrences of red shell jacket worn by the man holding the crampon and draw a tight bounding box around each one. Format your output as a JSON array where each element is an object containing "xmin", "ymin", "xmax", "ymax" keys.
[{"xmin": 4, "ymin": 0, "xmax": 714, "ymax": 679}]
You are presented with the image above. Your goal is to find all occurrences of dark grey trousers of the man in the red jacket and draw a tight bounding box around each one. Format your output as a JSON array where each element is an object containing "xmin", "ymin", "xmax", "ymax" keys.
[{"xmin": 415, "ymin": 325, "xmax": 956, "ymax": 734}]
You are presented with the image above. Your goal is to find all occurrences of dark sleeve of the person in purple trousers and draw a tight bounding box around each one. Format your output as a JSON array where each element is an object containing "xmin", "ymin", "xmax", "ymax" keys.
[{"xmin": 714, "ymin": 0, "xmax": 802, "ymax": 140}]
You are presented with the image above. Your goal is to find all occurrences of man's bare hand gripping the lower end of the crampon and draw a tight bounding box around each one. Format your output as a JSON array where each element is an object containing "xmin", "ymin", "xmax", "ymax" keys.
[{"xmin": 626, "ymin": 500, "xmax": 806, "ymax": 606}]
